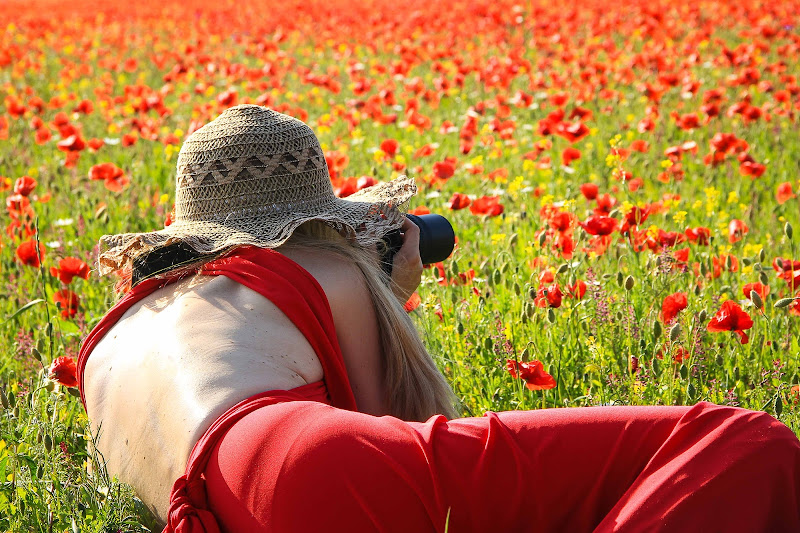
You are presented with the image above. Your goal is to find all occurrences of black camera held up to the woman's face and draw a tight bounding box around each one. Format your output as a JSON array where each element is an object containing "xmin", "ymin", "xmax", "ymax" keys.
[{"xmin": 381, "ymin": 214, "xmax": 456, "ymax": 276}]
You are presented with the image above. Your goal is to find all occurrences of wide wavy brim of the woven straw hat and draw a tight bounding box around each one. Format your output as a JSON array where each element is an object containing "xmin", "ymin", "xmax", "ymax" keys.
[{"xmin": 98, "ymin": 176, "xmax": 417, "ymax": 276}]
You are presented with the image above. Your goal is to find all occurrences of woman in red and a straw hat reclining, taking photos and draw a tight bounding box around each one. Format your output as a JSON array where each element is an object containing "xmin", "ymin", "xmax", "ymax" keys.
[{"xmin": 79, "ymin": 106, "xmax": 800, "ymax": 532}]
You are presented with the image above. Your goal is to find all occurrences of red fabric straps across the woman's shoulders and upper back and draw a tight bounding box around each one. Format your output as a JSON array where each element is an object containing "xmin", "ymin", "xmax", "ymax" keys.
[{"xmin": 77, "ymin": 246, "xmax": 356, "ymax": 410}]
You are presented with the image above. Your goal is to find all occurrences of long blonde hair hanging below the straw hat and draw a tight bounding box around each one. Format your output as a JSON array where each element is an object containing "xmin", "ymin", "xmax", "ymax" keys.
[{"xmin": 278, "ymin": 221, "xmax": 457, "ymax": 421}]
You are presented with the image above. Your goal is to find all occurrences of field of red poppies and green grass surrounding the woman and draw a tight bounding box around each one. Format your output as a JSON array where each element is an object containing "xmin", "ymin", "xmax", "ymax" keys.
[{"xmin": 0, "ymin": 0, "xmax": 800, "ymax": 531}]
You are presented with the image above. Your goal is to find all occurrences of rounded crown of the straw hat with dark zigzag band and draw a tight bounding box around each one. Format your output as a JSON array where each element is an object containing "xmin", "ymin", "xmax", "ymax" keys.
[{"xmin": 175, "ymin": 105, "xmax": 334, "ymax": 223}]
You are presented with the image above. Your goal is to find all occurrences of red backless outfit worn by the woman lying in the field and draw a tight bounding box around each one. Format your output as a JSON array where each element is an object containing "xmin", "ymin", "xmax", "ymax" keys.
[{"xmin": 79, "ymin": 247, "xmax": 800, "ymax": 533}]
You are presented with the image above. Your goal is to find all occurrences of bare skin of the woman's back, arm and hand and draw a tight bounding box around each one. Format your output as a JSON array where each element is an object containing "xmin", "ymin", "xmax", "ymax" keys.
[{"xmin": 85, "ymin": 221, "xmax": 422, "ymax": 521}]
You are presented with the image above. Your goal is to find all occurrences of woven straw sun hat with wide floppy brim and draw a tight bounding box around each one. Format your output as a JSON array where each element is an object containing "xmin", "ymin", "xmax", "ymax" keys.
[{"xmin": 98, "ymin": 105, "xmax": 416, "ymax": 275}]
